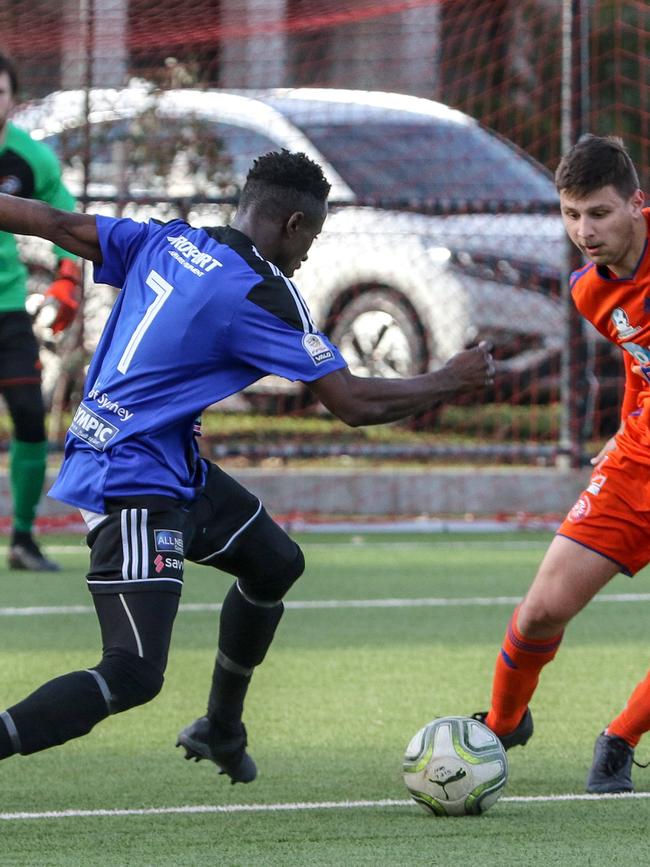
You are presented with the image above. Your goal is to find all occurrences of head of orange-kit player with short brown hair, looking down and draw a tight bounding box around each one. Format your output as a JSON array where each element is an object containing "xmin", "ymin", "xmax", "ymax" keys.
[{"xmin": 555, "ymin": 135, "xmax": 647, "ymax": 273}]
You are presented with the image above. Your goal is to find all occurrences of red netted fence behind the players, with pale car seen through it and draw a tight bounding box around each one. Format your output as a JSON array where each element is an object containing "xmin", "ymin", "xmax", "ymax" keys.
[{"xmin": 0, "ymin": 0, "xmax": 650, "ymax": 508}]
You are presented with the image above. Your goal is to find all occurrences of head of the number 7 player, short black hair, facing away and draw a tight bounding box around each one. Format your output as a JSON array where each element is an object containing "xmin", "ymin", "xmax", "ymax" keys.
[{"xmin": 233, "ymin": 150, "xmax": 330, "ymax": 277}]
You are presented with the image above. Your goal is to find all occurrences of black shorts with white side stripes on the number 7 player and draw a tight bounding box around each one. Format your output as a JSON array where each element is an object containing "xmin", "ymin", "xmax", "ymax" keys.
[{"xmin": 86, "ymin": 464, "xmax": 264, "ymax": 593}]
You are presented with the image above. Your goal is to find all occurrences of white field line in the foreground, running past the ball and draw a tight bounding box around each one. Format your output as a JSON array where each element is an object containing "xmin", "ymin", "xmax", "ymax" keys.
[{"xmin": 0, "ymin": 792, "xmax": 650, "ymax": 822}]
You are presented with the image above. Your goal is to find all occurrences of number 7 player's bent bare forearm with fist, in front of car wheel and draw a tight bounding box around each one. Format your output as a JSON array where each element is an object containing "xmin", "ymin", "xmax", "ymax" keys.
[{"xmin": 307, "ymin": 343, "xmax": 495, "ymax": 427}]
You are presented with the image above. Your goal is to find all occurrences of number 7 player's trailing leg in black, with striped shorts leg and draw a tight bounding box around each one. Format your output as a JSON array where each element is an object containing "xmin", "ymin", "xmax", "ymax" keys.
[{"xmin": 0, "ymin": 498, "xmax": 183, "ymax": 758}]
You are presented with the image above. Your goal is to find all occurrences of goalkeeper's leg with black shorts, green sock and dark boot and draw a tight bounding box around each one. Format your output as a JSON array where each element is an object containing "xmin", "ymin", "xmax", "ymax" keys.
[{"xmin": 0, "ymin": 311, "xmax": 58, "ymax": 571}]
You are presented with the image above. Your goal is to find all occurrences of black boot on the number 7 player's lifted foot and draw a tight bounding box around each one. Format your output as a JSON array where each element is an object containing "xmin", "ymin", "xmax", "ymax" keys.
[{"xmin": 176, "ymin": 716, "xmax": 257, "ymax": 784}]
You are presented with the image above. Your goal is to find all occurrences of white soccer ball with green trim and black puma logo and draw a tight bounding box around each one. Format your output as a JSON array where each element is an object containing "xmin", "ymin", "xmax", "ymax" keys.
[{"xmin": 403, "ymin": 716, "xmax": 508, "ymax": 816}]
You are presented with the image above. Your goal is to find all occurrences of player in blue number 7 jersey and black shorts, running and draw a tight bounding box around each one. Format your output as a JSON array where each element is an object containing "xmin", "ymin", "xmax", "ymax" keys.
[{"xmin": 0, "ymin": 151, "xmax": 494, "ymax": 782}]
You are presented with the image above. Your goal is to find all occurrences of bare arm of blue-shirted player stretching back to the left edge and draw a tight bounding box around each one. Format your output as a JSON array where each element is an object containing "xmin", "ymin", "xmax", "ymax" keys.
[{"xmin": 0, "ymin": 193, "xmax": 102, "ymax": 264}]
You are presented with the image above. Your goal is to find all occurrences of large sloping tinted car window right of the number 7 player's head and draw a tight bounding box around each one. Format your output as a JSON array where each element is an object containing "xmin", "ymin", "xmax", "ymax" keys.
[{"xmin": 280, "ymin": 118, "xmax": 557, "ymax": 204}]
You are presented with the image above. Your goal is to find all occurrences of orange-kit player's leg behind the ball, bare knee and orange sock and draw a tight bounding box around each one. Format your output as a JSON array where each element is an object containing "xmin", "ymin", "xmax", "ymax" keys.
[{"xmin": 485, "ymin": 536, "xmax": 619, "ymax": 747}]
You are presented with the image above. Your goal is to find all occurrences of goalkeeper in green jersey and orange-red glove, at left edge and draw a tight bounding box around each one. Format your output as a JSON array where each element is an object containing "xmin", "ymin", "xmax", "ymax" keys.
[{"xmin": 0, "ymin": 55, "xmax": 80, "ymax": 571}]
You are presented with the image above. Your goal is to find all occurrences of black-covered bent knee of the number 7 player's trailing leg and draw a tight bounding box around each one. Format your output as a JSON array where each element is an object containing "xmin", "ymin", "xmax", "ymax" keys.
[{"xmin": 94, "ymin": 648, "xmax": 164, "ymax": 713}]
